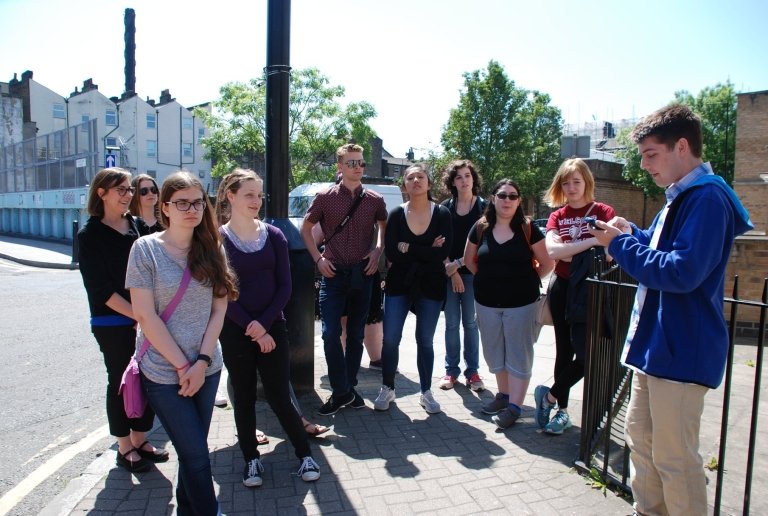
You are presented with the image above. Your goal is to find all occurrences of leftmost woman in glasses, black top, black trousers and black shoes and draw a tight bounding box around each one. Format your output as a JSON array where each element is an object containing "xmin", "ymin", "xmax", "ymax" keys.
[{"xmin": 77, "ymin": 168, "xmax": 168, "ymax": 472}]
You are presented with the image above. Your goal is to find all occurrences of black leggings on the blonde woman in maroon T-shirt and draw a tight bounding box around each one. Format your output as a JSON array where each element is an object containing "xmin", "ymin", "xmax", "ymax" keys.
[{"xmin": 549, "ymin": 276, "xmax": 587, "ymax": 409}]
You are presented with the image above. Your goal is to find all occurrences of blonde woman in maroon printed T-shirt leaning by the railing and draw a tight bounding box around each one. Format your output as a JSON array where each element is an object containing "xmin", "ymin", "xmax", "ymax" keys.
[{"xmin": 534, "ymin": 158, "xmax": 616, "ymax": 435}]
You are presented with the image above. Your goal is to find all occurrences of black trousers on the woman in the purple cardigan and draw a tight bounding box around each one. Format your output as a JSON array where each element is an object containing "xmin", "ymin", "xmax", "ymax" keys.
[{"xmin": 219, "ymin": 318, "xmax": 311, "ymax": 461}]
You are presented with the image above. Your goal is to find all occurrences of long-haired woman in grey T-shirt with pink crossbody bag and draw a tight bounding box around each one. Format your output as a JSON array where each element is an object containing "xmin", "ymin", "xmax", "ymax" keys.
[{"xmin": 125, "ymin": 172, "xmax": 237, "ymax": 515}]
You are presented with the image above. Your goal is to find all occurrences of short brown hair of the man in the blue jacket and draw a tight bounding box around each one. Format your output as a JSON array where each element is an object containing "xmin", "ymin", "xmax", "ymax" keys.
[{"xmin": 629, "ymin": 104, "xmax": 703, "ymax": 158}]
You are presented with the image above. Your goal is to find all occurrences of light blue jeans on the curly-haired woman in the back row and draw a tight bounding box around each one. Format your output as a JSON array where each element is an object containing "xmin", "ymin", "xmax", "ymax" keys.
[{"xmin": 445, "ymin": 274, "xmax": 480, "ymax": 379}]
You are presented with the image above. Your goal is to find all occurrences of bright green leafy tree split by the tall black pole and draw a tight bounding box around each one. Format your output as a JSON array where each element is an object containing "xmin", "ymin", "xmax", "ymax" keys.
[{"xmin": 195, "ymin": 68, "xmax": 376, "ymax": 188}]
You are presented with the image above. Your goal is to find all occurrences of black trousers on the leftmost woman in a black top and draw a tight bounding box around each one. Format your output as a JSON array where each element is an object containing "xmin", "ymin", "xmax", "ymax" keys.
[{"xmin": 91, "ymin": 326, "xmax": 155, "ymax": 437}]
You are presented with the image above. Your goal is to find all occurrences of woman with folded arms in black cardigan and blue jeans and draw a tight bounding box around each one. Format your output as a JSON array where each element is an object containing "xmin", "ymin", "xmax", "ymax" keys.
[{"xmin": 373, "ymin": 165, "xmax": 453, "ymax": 414}]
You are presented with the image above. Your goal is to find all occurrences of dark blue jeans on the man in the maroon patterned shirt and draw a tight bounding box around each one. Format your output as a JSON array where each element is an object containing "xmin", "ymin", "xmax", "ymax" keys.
[{"xmin": 320, "ymin": 263, "xmax": 373, "ymax": 398}]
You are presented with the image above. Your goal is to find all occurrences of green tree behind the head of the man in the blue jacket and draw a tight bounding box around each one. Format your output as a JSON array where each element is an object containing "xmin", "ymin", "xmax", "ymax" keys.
[{"xmin": 675, "ymin": 81, "xmax": 737, "ymax": 185}]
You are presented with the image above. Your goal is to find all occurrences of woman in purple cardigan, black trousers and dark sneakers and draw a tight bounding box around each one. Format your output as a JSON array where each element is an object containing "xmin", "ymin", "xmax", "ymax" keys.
[{"xmin": 216, "ymin": 169, "xmax": 320, "ymax": 487}]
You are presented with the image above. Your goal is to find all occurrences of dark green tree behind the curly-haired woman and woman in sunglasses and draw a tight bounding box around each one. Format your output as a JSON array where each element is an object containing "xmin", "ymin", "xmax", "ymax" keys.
[{"xmin": 441, "ymin": 61, "xmax": 562, "ymax": 205}]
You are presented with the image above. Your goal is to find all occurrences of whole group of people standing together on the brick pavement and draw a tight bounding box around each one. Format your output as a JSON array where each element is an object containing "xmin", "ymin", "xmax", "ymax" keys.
[{"xmin": 78, "ymin": 105, "xmax": 752, "ymax": 515}]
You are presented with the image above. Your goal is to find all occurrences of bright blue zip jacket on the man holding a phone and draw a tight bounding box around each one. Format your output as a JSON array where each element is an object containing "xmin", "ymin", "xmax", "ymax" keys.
[{"xmin": 608, "ymin": 175, "xmax": 753, "ymax": 389}]
